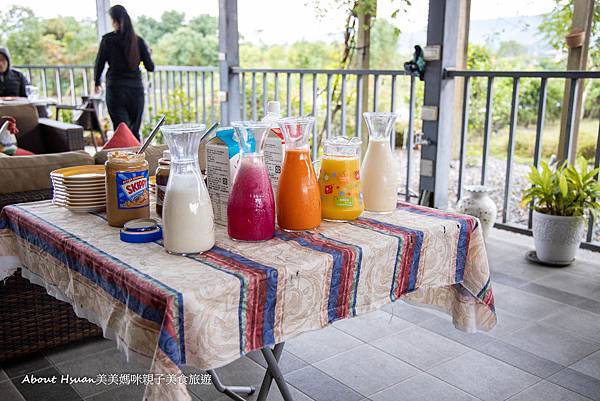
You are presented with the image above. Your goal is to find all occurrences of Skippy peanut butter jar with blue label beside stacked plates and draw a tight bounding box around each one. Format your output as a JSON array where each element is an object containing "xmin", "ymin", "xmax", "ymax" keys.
[{"xmin": 105, "ymin": 151, "xmax": 150, "ymax": 227}]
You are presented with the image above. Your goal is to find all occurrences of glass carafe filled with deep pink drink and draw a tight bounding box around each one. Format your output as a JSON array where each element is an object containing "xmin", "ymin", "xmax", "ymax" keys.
[{"xmin": 227, "ymin": 121, "xmax": 275, "ymax": 241}]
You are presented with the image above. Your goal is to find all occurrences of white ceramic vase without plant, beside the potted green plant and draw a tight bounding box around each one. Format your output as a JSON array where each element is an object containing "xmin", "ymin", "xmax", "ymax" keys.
[{"xmin": 456, "ymin": 185, "xmax": 498, "ymax": 239}]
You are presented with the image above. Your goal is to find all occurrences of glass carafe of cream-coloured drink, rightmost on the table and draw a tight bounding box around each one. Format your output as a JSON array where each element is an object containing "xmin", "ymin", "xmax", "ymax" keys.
[{"xmin": 360, "ymin": 113, "xmax": 398, "ymax": 213}]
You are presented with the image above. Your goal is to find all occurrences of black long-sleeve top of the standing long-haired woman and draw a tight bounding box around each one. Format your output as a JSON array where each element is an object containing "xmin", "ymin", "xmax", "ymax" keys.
[{"xmin": 94, "ymin": 32, "xmax": 154, "ymax": 87}]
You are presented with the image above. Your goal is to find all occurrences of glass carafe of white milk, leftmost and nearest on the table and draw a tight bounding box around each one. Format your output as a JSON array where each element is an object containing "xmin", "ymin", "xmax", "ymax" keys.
[{"xmin": 161, "ymin": 124, "xmax": 215, "ymax": 255}]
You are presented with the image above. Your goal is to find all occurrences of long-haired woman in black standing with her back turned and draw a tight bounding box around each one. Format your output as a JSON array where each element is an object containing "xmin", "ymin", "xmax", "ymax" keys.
[{"xmin": 94, "ymin": 5, "xmax": 154, "ymax": 139}]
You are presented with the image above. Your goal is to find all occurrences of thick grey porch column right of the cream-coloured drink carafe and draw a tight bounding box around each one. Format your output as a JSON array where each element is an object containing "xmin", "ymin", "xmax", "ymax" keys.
[{"xmin": 419, "ymin": 0, "xmax": 469, "ymax": 209}]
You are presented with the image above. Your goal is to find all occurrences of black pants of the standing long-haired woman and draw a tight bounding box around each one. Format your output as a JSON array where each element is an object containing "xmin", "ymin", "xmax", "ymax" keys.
[{"xmin": 106, "ymin": 85, "xmax": 144, "ymax": 139}]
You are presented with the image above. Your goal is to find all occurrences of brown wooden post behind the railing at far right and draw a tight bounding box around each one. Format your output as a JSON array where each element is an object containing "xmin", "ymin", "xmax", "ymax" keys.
[{"xmin": 558, "ymin": 0, "xmax": 594, "ymax": 162}]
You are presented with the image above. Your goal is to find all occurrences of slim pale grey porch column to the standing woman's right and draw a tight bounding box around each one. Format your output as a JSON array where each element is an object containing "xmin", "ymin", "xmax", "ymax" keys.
[{"xmin": 219, "ymin": 0, "xmax": 240, "ymax": 125}]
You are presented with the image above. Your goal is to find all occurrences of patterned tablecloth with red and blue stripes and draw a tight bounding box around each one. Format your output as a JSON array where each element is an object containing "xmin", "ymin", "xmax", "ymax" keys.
[{"xmin": 0, "ymin": 201, "xmax": 496, "ymax": 400}]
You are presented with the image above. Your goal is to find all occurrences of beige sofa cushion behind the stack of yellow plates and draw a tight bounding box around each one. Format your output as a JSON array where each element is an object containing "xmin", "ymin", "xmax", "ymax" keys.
[{"xmin": 0, "ymin": 150, "xmax": 94, "ymax": 194}]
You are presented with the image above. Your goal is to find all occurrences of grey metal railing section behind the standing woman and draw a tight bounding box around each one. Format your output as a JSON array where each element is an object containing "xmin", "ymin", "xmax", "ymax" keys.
[{"xmin": 15, "ymin": 65, "xmax": 218, "ymax": 123}]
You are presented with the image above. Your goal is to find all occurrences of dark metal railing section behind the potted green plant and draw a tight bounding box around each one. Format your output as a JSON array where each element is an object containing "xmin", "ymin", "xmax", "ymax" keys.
[{"xmin": 445, "ymin": 70, "xmax": 600, "ymax": 251}]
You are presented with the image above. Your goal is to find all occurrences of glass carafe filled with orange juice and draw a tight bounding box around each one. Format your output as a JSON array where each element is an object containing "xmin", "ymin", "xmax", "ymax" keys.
[{"xmin": 277, "ymin": 117, "xmax": 321, "ymax": 231}]
